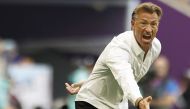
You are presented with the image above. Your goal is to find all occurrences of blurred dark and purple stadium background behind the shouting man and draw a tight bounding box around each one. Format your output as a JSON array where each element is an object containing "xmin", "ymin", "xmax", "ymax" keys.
[{"xmin": 0, "ymin": 0, "xmax": 190, "ymax": 109}]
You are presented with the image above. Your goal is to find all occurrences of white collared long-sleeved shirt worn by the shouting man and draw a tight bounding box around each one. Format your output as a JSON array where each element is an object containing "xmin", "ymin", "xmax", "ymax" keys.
[{"xmin": 76, "ymin": 31, "xmax": 161, "ymax": 109}]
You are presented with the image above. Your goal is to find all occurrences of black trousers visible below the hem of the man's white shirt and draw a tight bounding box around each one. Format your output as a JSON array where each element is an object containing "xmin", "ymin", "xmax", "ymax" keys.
[{"xmin": 75, "ymin": 101, "xmax": 97, "ymax": 109}]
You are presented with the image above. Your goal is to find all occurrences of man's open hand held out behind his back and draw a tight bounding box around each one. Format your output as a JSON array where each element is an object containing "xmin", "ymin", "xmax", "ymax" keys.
[{"xmin": 65, "ymin": 83, "xmax": 82, "ymax": 95}]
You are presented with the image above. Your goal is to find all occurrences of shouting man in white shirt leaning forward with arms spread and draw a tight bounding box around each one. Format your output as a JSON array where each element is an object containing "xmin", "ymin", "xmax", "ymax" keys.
[{"xmin": 66, "ymin": 2, "xmax": 162, "ymax": 109}]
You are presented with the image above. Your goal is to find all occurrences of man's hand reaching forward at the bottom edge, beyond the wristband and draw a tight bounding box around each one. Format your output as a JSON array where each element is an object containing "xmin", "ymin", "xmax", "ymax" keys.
[{"xmin": 138, "ymin": 96, "xmax": 152, "ymax": 109}]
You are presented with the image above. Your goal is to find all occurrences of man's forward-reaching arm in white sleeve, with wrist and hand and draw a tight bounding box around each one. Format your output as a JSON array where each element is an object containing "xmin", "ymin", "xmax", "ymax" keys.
[{"xmin": 106, "ymin": 48, "xmax": 151, "ymax": 109}]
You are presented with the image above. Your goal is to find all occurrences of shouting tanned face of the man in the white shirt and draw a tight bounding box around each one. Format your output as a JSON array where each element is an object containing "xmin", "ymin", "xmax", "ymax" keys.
[{"xmin": 132, "ymin": 11, "xmax": 159, "ymax": 52}]
